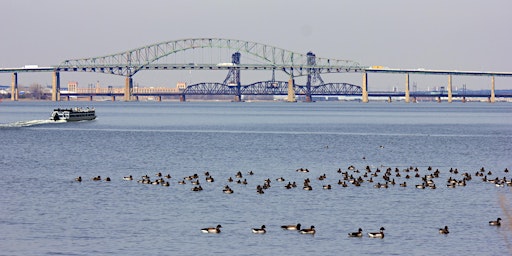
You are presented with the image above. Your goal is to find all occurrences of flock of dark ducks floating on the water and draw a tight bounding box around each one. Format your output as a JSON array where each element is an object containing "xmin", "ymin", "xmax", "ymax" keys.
[{"xmin": 75, "ymin": 165, "xmax": 512, "ymax": 238}]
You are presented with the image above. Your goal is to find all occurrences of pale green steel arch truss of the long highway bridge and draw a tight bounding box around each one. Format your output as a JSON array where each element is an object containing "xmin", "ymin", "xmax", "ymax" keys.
[{"xmin": 57, "ymin": 38, "xmax": 368, "ymax": 77}]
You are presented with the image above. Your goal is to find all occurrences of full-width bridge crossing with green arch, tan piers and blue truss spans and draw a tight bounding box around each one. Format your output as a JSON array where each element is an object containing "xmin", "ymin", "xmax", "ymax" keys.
[{"xmin": 0, "ymin": 38, "xmax": 512, "ymax": 102}]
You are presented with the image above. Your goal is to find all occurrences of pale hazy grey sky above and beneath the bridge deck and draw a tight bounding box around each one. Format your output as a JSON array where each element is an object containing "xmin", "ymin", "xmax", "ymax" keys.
[{"xmin": 0, "ymin": 0, "xmax": 512, "ymax": 90}]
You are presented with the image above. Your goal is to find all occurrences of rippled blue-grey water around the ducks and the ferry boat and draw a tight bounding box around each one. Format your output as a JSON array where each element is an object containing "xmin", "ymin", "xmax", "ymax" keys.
[{"xmin": 0, "ymin": 101, "xmax": 512, "ymax": 255}]
